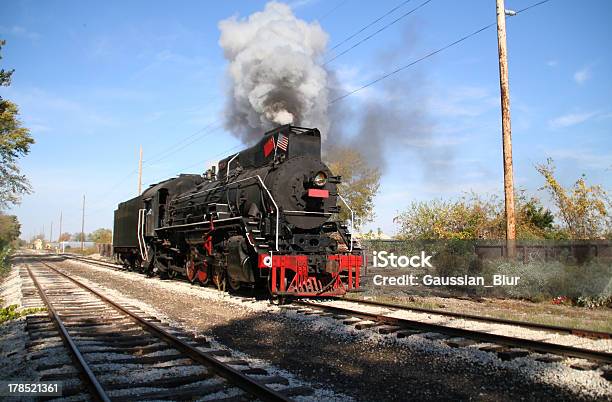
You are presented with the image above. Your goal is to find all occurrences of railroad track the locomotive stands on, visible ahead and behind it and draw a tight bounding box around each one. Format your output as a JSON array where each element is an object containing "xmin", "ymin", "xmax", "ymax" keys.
[{"xmin": 61, "ymin": 254, "xmax": 612, "ymax": 368}]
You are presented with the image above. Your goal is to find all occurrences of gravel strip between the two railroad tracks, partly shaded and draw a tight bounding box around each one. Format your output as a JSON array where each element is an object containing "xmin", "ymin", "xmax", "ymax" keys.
[{"xmin": 32, "ymin": 261, "xmax": 612, "ymax": 401}]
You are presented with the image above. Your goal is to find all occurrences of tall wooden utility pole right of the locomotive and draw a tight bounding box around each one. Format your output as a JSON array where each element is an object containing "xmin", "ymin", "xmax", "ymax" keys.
[{"xmin": 496, "ymin": 0, "xmax": 516, "ymax": 259}]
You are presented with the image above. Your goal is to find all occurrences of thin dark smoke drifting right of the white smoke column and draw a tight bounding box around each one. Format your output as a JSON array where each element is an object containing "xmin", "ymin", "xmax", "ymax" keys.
[{"xmin": 328, "ymin": 26, "xmax": 444, "ymax": 179}]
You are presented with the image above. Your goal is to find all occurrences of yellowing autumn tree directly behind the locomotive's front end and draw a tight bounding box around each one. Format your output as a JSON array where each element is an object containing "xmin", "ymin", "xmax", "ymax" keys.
[{"xmin": 325, "ymin": 146, "xmax": 380, "ymax": 228}]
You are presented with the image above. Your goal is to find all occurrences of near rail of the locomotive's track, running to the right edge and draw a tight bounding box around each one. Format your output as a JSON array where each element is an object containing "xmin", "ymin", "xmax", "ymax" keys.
[{"xmin": 294, "ymin": 301, "xmax": 612, "ymax": 363}]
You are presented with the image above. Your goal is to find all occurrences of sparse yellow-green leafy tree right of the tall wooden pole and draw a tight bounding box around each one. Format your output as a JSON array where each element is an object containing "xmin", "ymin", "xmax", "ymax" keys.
[{"xmin": 536, "ymin": 158, "xmax": 612, "ymax": 239}]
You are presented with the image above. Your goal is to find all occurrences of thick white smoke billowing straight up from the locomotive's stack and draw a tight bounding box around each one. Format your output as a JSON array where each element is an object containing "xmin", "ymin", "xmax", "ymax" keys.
[{"xmin": 219, "ymin": 2, "xmax": 330, "ymax": 142}]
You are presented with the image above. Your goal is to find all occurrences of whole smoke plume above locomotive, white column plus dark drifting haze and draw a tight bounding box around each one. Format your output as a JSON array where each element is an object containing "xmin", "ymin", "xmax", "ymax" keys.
[{"xmin": 219, "ymin": 2, "xmax": 444, "ymax": 178}]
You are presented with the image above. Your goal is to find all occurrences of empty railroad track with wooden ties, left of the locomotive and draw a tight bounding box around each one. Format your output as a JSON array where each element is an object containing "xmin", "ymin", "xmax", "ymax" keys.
[{"xmin": 27, "ymin": 260, "xmax": 313, "ymax": 401}]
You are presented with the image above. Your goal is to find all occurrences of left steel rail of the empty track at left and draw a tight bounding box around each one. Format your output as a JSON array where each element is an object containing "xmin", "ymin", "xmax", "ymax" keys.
[{"xmin": 26, "ymin": 265, "xmax": 111, "ymax": 402}]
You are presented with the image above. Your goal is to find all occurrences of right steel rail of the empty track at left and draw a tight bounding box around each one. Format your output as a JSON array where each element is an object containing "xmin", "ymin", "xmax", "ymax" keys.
[{"xmin": 39, "ymin": 260, "xmax": 291, "ymax": 402}]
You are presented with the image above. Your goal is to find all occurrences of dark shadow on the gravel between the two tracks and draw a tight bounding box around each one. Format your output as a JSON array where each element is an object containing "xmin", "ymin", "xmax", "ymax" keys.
[{"xmin": 206, "ymin": 314, "xmax": 596, "ymax": 401}]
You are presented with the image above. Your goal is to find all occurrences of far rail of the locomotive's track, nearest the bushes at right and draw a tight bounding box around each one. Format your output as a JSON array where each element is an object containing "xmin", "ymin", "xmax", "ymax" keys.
[{"xmin": 343, "ymin": 299, "xmax": 612, "ymax": 339}]
